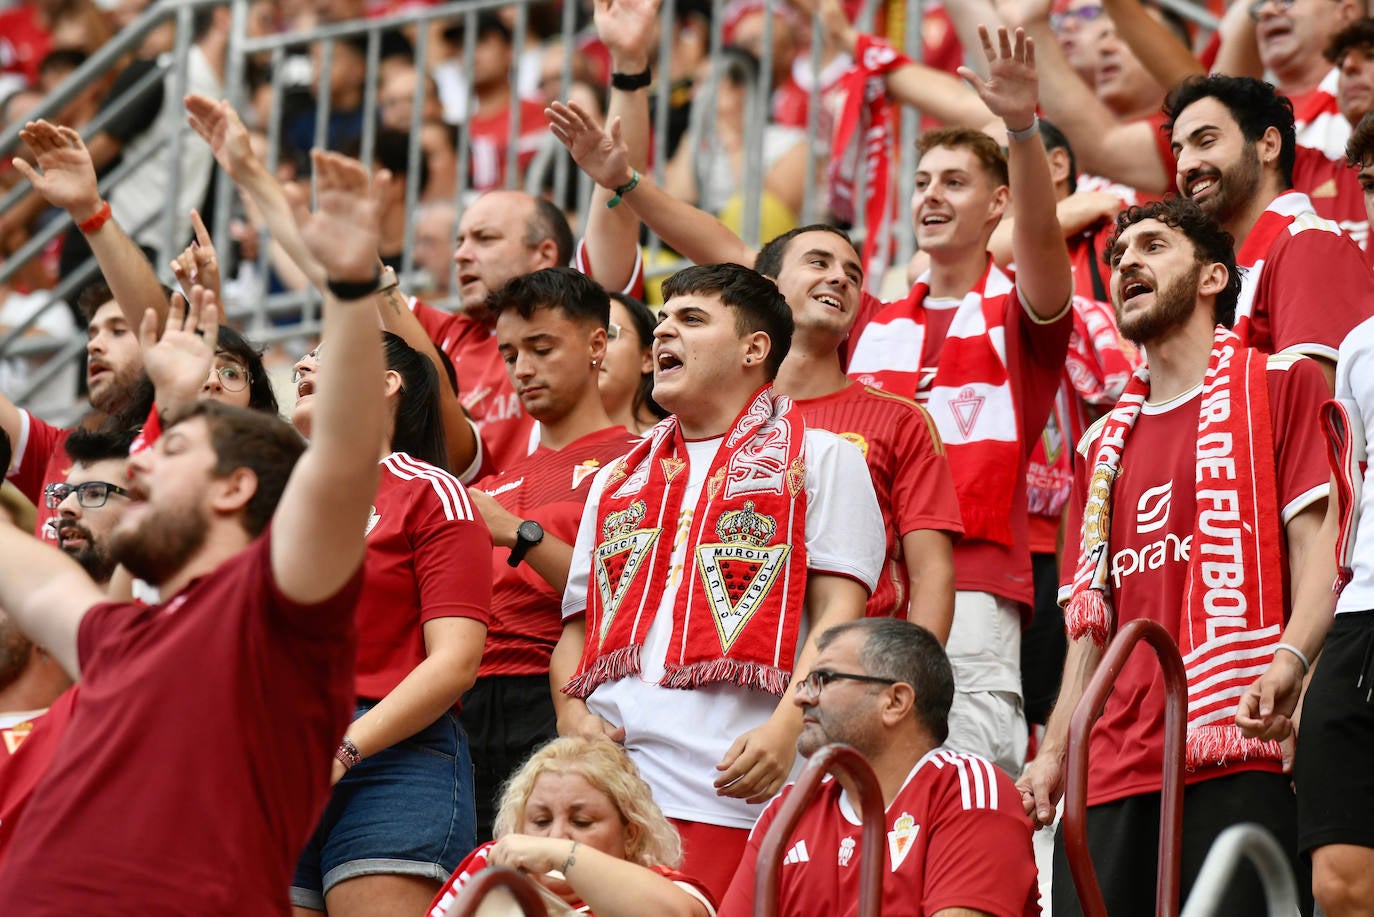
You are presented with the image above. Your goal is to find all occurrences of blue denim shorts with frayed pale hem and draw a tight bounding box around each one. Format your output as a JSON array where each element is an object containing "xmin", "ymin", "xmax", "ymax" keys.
[{"xmin": 291, "ymin": 701, "xmax": 477, "ymax": 910}]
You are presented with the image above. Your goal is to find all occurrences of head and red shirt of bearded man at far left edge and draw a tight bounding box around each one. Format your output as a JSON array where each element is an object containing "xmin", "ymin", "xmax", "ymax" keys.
[{"xmin": 0, "ymin": 283, "xmax": 153, "ymax": 543}]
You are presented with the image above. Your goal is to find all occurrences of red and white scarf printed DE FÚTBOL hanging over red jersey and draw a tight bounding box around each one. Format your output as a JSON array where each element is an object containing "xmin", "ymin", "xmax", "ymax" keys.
[{"xmin": 1065, "ymin": 327, "xmax": 1285, "ymax": 770}]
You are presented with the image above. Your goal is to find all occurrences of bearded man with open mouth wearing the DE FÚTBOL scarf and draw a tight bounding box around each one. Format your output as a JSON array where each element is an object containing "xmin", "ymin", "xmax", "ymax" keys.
[{"xmin": 1017, "ymin": 198, "xmax": 1333, "ymax": 917}]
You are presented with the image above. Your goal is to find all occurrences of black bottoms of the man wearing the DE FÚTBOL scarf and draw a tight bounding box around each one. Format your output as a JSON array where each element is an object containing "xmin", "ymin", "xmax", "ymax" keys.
[{"xmin": 1051, "ymin": 771, "xmax": 1312, "ymax": 917}]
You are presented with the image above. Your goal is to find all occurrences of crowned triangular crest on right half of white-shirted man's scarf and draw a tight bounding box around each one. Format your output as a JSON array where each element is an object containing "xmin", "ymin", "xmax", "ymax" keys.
[{"xmin": 697, "ymin": 500, "xmax": 791, "ymax": 653}]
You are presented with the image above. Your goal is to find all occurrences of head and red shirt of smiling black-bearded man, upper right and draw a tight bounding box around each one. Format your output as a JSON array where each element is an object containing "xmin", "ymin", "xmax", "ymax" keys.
[{"xmin": 1164, "ymin": 76, "xmax": 1374, "ymax": 388}]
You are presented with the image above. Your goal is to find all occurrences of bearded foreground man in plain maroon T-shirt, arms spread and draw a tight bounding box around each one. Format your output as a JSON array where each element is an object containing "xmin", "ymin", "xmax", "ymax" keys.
[{"xmin": 0, "ymin": 151, "xmax": 386, "ymax": 916}]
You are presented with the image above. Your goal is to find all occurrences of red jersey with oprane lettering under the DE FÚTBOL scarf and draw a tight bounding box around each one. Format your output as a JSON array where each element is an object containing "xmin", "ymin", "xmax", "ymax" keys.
[{"xmin": 1061, "ymin": 356, "xmax": 1330, "ymax": 806}]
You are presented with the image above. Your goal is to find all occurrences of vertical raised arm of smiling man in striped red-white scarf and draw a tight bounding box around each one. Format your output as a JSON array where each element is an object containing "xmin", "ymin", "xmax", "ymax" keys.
[{"xmin": 959, "ymin": 27, "xmax": 1073, "ymax": 319}]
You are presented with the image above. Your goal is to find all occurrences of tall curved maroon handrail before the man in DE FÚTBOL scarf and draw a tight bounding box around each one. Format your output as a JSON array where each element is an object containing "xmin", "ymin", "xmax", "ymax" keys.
[{"xmin": 1063, "ymin": 620, "xmax": 1187, "ymax": 917}]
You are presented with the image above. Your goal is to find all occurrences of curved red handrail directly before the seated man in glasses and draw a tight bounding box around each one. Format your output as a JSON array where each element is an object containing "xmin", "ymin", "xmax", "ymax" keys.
[{"xmin": 754, "ymin": 744, "xmax": 888, "ymax": 917}]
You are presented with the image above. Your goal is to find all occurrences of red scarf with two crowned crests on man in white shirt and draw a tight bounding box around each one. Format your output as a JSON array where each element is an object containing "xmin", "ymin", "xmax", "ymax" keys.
[{"xmin": 563, "ymin": 385, "xmax": 807, "ymax": 698}]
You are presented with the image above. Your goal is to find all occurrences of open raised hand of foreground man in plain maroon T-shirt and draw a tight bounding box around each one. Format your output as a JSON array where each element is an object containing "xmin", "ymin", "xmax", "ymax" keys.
[{"xmin": 297, "ymin": 150, "xmax": 392, "ymax": 282}]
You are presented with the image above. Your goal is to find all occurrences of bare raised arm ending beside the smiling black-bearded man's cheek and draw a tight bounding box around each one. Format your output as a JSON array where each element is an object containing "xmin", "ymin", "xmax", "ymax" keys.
[{"xmin": 1011, "ymin": 0, "xmax": 1173, "ymax": 194}]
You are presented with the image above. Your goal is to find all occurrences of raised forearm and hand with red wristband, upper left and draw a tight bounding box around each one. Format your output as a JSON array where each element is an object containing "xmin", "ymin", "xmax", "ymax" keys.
[{"xmin": 14, "ymin": 121, "xmax": 168, "ymax": 327}]
